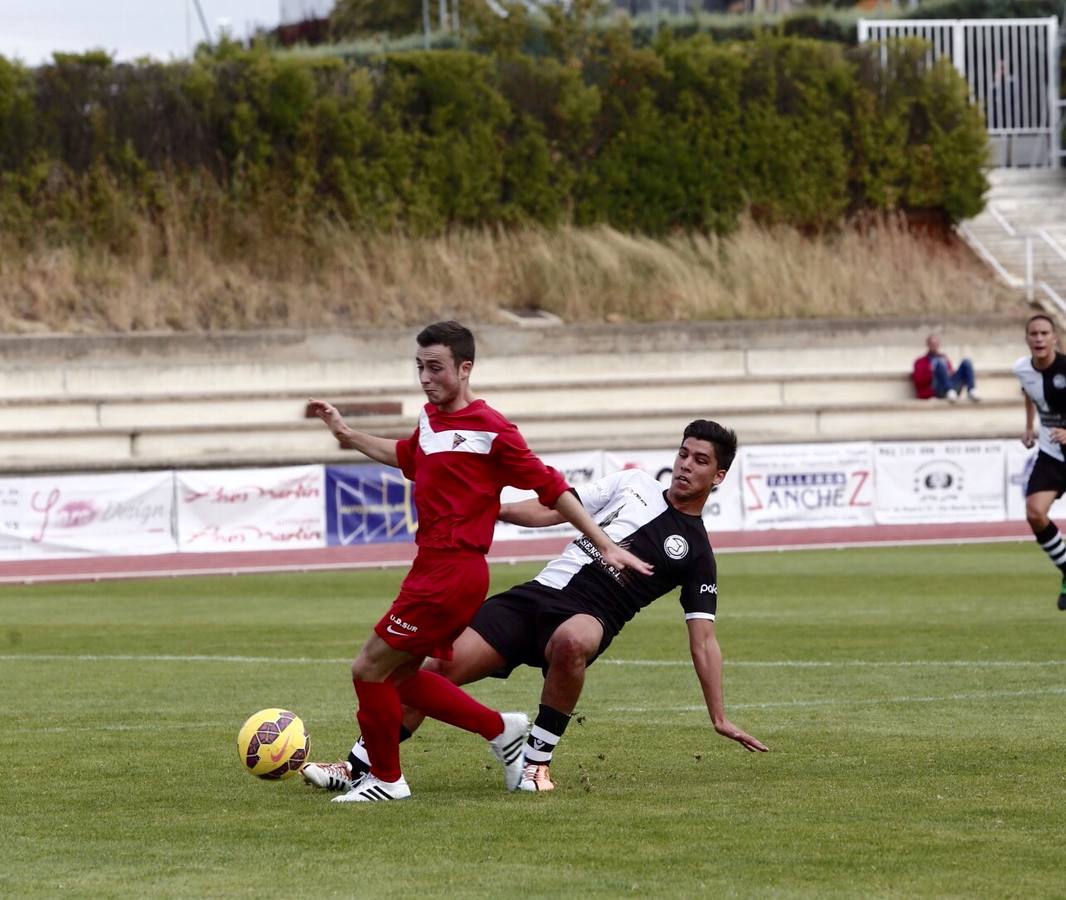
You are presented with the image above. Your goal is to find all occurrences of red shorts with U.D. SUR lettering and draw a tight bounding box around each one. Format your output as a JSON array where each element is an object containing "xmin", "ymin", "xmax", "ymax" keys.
[{"xmin": 374, "ymin": 549, "xmax": 488, "ymax": 659}]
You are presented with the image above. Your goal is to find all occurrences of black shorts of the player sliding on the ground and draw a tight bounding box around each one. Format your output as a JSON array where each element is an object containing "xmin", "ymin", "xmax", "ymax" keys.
[{"xmin": 470, "ymin": 581, "xmax": 618, "ymax": 678}]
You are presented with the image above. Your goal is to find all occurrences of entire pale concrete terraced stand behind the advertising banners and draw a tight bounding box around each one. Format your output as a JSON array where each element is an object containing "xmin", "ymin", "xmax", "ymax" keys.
[{"xmin": 0, "ymin": 315, "xmax": 1025, "ymax": 473}]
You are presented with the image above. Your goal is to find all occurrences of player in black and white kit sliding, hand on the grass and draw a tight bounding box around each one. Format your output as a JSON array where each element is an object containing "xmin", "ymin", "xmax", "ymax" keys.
[{"xmin": 303, "ymin": 419, "xmax": 766, "ymax": 791}]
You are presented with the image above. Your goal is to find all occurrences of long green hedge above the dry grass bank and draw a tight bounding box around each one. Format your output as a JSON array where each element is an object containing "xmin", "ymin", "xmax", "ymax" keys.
[{"xmin": 0, "ymin": 35, "xmax": 986, "ymax": 251}]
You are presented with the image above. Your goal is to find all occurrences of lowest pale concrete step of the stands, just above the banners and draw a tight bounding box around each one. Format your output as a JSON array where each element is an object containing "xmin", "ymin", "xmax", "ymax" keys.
[{"xmin": 0, "ymin": 400, "xmax": 1023, "ymax": 475}]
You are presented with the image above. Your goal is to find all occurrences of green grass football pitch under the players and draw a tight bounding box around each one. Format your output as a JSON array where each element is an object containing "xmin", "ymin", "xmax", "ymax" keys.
[{"xmin": 0, "ymin": 544, "xmax": 1066, "ymax": 898}]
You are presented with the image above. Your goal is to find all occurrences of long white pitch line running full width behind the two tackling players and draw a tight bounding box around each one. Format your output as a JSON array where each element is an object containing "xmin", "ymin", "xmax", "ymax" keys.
[{"xmin": 0, "ymin": 654, "xmax": 1066, "ymax": 669}]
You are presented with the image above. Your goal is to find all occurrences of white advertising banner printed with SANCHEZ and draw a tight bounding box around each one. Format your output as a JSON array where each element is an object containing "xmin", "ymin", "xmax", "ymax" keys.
[{"xmin": 741, "ymin": 441, "xmax": 874, "ymax": 529}]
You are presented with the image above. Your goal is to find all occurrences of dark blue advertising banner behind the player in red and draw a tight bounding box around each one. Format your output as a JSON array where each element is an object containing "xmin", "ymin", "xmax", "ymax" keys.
[{"xmin": 325, "ymin": 465, "xmax": 418, "ymax": 547}]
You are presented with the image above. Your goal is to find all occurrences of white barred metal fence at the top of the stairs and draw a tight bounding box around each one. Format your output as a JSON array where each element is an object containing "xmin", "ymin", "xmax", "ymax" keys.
[{"xmin": 858, "ymin": 16, "xmax": 1064, "ymax": 166}]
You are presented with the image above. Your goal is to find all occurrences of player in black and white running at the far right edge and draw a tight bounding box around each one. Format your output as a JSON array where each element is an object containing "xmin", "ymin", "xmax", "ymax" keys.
[{"xmin": 1014, "ymin": 315, "xmax": 1066, "ymax": 611}]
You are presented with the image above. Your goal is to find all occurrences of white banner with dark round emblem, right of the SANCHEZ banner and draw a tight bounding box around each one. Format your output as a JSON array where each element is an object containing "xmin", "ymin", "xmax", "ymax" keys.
[{"xmin": 874, "ymin": 440, "xmax": 1006, "ymax": 525}]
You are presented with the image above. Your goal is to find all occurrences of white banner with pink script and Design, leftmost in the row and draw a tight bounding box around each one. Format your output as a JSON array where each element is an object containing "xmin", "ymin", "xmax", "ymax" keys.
[{"xmin": 0, "ymin": 471, "xmax": 177, "ymax": 560}]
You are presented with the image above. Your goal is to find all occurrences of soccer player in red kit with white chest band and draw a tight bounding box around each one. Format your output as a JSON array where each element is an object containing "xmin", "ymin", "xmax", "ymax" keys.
[{"xmin": 310, "ymin": 322, "xmax": 651, "ymax": 803}]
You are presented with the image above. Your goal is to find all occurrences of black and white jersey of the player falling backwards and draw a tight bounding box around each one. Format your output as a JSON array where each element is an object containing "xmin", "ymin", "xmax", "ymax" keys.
[{"xmin": 535, "ymin": 469, "xmax": 718, "ymax": 630}]
